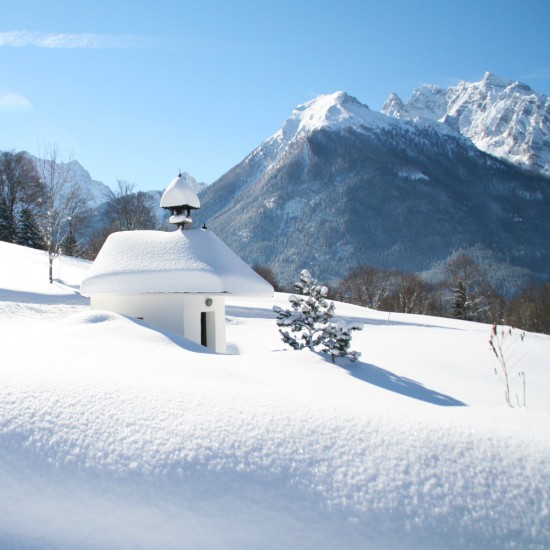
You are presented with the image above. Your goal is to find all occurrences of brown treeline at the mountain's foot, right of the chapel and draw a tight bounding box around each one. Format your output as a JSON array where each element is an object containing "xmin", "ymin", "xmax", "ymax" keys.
[{"xmin": 255, "ymin": 253, "xmax": 550, "ymax": 334}]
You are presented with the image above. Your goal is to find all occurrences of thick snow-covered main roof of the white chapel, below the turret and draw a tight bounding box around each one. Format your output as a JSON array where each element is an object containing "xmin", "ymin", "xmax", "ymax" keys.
[{"xmin": 80, "ymin": 229, "xmax": 273, "ymax": 296}]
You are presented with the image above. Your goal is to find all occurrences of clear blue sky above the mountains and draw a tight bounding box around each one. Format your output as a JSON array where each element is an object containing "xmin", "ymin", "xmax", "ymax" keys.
[{"xmin": 0, "ymin": 0, "xmax": 550, "ymax": 189}]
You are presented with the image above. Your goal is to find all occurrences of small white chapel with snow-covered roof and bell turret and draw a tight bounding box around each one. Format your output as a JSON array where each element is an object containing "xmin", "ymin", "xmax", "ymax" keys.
[{"xmin": 80, "ymin": 174, "xmax": 273, "ymax": 353}]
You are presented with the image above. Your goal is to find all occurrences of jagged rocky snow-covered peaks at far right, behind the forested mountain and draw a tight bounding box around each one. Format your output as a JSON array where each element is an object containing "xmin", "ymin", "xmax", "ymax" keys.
[{"xmin": 382, "ymin": 73, "xmax": 550, "ymax": 175}]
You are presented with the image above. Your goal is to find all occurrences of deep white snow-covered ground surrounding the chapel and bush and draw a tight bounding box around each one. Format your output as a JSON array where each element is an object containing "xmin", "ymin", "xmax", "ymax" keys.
[{"xmin": 0, "ymin": 243, "xmax": 550, "ymax": 550}]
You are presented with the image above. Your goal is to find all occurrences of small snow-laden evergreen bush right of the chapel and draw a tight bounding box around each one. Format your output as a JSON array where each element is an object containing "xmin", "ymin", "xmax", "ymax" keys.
[{"xmin": 273, "ymin": 269, "xmax": 363, "ymax": 362}]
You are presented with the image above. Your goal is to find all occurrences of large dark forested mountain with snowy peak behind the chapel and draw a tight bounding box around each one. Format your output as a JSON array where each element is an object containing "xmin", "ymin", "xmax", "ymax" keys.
[{"xmin": 194, "ymin": 92, "xmax": 550, "ymax": 294}]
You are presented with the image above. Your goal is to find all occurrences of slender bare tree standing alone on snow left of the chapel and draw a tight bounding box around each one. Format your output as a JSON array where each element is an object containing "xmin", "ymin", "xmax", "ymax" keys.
[{"xmin": 36, "ymin": 145, "xmax": 89, "ymax": 284}]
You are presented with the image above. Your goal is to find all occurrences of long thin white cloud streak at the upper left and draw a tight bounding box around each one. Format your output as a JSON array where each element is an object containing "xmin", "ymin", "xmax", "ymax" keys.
[{"xmin": 0, "ymin": 31, "xmax": 152, "ymax": 50}]
